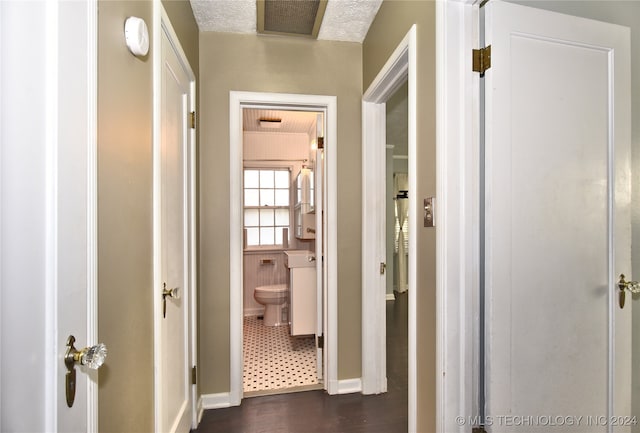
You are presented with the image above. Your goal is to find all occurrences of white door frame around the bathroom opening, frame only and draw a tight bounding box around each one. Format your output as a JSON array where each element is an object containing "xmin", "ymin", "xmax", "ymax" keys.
[{"xmin": 229, "ymin": 91, "xmax": 339, "ymax": 406}]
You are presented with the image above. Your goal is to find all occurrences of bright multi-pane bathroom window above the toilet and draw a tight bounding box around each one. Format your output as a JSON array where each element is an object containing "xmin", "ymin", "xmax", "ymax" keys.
[{"xmin": 244, "ymin": 168, "xmax": 291, "ymax": 247}]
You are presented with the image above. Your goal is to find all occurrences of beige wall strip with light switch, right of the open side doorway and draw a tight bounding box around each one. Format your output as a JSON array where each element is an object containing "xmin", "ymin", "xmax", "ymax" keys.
[{"xmin": 362, "ymin": 0, "xmax": 436, "ymax": 432}]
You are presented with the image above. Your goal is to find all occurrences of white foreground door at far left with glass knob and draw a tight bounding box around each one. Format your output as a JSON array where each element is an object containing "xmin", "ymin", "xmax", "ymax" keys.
[{"xmin": 0, "ymin": 0, "xmax": 97, "ymax": 432}]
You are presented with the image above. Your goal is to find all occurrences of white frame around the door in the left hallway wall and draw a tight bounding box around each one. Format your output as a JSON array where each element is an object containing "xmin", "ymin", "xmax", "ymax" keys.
[{"xmin": 151, "ymin": 0, "xmax": 198, "ymax": 430}]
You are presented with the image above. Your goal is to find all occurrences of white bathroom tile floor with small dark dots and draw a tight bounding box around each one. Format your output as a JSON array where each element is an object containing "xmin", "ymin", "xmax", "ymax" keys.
[{"xmin": 243, "ymin": 316, "xmax": 318, "ymax": 392}]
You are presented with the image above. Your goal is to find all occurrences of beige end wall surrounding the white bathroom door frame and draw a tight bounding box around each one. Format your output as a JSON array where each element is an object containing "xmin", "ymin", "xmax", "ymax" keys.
[{"xmin": 198, "ymin": 32, "xmax": 362, "ymax": 394}]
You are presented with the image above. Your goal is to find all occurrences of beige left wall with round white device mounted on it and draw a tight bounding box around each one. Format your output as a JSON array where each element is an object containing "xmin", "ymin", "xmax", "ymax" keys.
[{"xmin": 98, "ymin": 0, "xmax": 198, "ymax": 433}]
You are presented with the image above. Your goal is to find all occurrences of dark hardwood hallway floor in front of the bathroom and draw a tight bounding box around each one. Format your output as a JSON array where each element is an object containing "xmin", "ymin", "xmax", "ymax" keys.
[{"xmin": 194, "ymin": 292, "xmax": 408, "ymax": 433}]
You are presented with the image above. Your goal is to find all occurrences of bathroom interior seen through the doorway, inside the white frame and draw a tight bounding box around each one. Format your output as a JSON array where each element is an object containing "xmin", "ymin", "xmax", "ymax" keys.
[{"xmin": 242, "ymin": 107, "xmax": 324, "ymax": 397}]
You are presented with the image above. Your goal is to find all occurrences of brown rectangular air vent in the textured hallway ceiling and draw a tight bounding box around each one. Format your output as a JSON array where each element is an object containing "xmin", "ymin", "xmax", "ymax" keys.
[{"xmin": 256, "ymin": 0, "xmax": 327, "ymax": 39}]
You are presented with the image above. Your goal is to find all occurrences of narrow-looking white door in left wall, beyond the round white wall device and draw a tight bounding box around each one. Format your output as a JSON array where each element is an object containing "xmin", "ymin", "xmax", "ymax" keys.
[{"xmin": 156, "ymin": 24, "xmax": 193, "ymax": 432}]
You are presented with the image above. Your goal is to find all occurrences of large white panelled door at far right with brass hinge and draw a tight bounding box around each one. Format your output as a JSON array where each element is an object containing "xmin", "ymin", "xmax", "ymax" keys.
[{"xmin": 485, "ymin": 1, "xmax": 631, "ymax": 432}]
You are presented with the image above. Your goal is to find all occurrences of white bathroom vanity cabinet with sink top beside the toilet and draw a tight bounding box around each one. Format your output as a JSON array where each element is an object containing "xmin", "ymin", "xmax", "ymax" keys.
[{"xmin": 284, "ymin": 250, "xmax": 317, "ymax": 336}]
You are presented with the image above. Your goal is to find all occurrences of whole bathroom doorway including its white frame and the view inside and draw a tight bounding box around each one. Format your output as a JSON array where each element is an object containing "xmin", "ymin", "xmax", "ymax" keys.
[{"xmin": 230, "ymin": 92, "xmax": 337, "ymax": 405}]
